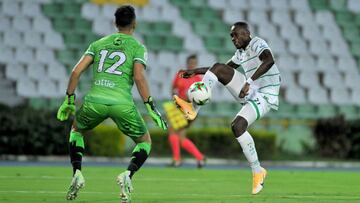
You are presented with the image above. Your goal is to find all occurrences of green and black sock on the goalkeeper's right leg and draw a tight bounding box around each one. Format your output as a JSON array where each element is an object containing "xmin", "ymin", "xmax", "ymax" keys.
[{"xmin": 127, "ymin": 142, "xmax": 151, "ymax": 178}]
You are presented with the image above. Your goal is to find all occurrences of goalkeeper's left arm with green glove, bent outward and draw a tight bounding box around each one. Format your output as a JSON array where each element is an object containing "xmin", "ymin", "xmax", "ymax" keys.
[{"xmin": 56, "ymin": 55, "xmax": 93, "ymax": 121}]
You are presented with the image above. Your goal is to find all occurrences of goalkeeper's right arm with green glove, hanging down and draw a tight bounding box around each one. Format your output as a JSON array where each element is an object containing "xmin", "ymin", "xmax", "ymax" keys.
[{"xmin": 134, "ymin": 62, "xmax": 167, "ymax": 130}]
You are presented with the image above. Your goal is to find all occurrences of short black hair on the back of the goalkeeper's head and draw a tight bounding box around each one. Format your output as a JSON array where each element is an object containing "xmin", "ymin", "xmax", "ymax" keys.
[{"xmin": 114, "ymin": 5, "xmax": 136, "ymax": 27}]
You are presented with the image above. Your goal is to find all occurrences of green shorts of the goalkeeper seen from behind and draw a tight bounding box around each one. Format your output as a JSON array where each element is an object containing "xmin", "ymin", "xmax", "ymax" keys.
[{"xmin": 75, "ymin": 102, "xmax": 147, "ymax": 137}]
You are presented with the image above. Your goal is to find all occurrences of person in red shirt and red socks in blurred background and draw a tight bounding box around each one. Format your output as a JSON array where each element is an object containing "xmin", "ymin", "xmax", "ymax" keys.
[{"xmin": 168, "ymin": 55, "xmax": 205, "ymax": 168}]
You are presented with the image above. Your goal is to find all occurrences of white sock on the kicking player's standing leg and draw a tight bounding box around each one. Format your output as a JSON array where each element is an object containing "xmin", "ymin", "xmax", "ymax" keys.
[{"xmin": 236, "ymin": 131, "xmax": 261, "ymax": 173}]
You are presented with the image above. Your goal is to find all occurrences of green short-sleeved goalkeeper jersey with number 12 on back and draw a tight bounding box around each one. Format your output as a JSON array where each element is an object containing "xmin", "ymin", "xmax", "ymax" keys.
[{"xmin": 85, "ymin": 33, "xmax": 147, "ymax": 105}]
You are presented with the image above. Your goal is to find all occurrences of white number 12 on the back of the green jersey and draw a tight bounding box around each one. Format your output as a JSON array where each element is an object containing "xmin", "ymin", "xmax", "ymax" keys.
[{"xmin": 98, "ymin": 50, "xmax": 126, "ymax": 75}]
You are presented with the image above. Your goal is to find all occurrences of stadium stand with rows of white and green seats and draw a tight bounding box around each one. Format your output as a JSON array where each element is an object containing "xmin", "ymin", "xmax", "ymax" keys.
[{"xmin": 0, "ymin": 0, "xmax": 360, "ymax": 150}]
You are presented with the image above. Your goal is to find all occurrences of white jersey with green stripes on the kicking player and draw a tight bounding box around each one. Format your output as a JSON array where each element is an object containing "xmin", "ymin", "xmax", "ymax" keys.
[{"xmin": 231, "ymin": 37, "xmax": 281, "ymax": 109}]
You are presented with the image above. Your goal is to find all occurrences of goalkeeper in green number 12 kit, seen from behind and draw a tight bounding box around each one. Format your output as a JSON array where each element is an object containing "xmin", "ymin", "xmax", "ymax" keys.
[{"xmin": 57, "ymin": 6, "xmax": 167, "ymax": 202}]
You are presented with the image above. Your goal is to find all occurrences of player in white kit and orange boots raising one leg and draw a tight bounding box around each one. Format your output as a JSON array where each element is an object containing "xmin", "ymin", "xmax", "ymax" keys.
[{"xmin": 174, "ymin": 22, "xmax": 281, "ymax": 194}]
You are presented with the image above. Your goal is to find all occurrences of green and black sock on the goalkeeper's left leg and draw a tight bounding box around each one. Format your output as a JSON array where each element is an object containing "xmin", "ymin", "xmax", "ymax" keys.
[{"xmin": 69, "ymin": 131, "xmax": 85, "ymax": 175}]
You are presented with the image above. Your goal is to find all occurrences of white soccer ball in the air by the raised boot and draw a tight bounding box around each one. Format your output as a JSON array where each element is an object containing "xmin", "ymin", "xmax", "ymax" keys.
[{"xmin": 188, "ymin": 82, "xmax": 211, "ymax": 106}]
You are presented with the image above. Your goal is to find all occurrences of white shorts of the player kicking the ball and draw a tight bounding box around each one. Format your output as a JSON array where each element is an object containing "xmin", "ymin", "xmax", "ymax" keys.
[{"xmin": 225, "ymin": 71, "xmax": 271, "ymax": 125}]
